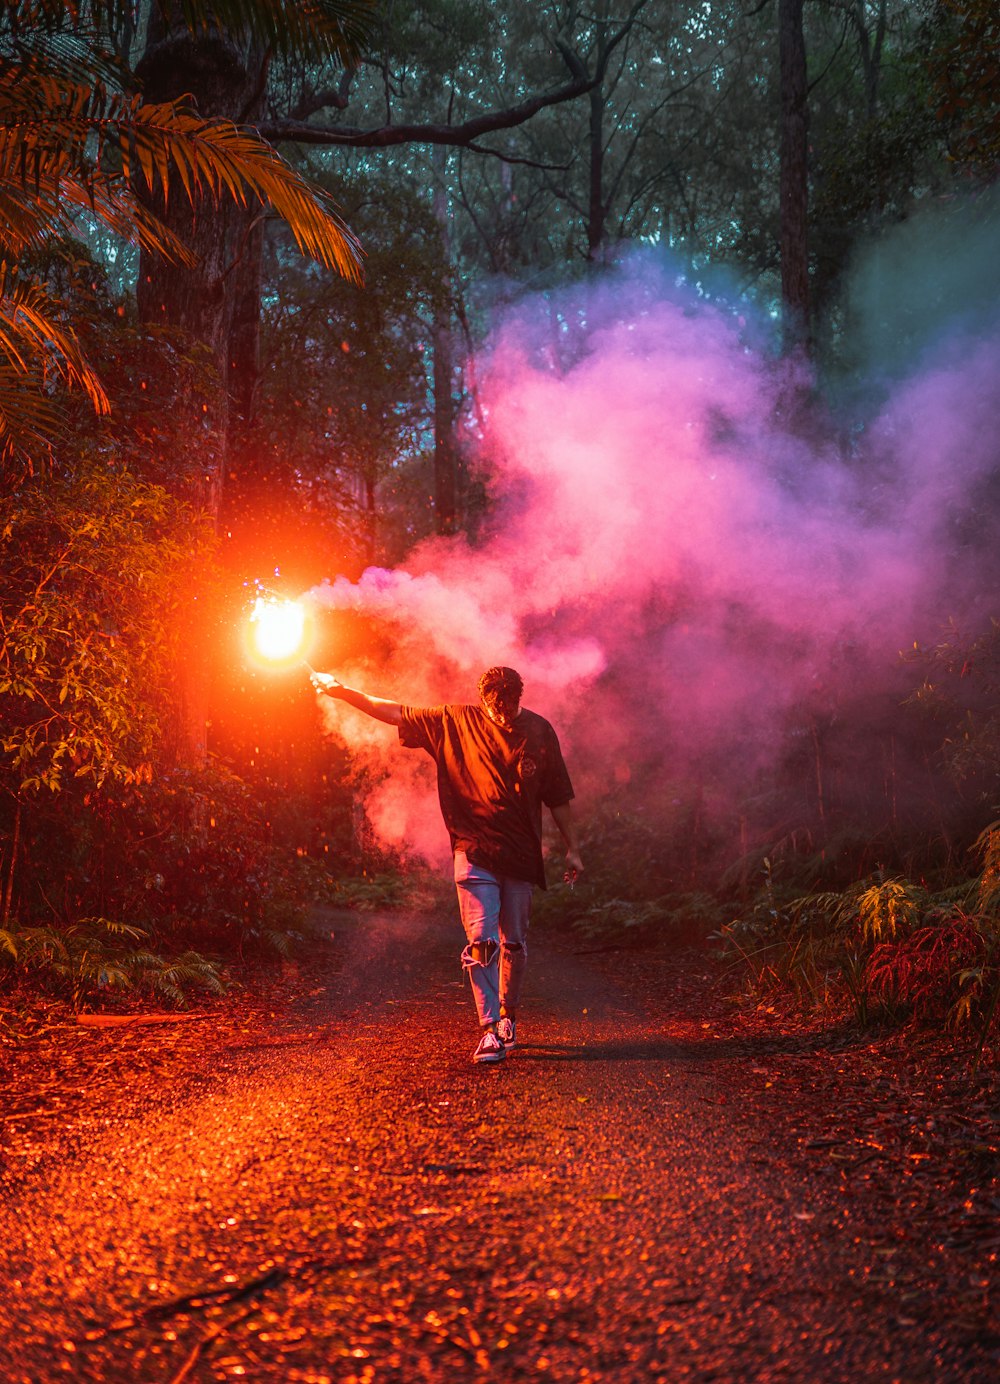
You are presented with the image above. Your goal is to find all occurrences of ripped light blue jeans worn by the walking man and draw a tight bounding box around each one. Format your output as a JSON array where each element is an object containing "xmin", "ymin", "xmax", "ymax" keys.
[{"xmin": 455, "ymin": 851, "xmax": 534, "ymax": 1028}]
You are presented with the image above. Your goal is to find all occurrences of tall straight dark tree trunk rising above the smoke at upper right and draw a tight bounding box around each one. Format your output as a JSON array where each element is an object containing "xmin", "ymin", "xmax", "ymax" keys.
[{"xmin": 777, "ymin": 0, "xmax": 809, "ymax": 350}]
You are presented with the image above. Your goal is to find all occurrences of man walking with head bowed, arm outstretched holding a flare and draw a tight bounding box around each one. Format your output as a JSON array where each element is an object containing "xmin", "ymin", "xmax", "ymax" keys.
[{"xmin": 313, "ymin": 667, "xmax": 584, "ymax": 1063}]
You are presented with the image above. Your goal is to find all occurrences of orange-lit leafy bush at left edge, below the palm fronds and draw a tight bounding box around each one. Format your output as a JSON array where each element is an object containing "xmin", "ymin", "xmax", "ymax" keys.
[{"xmin": 0, "ymin": 462, "xmax": 207, "ymax": 797}]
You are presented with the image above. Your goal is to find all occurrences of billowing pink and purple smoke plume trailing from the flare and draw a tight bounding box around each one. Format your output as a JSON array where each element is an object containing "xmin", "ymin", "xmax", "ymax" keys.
[{"xmin": 310, "ymin": 202, "xmax": 1000, "ymax": 874}]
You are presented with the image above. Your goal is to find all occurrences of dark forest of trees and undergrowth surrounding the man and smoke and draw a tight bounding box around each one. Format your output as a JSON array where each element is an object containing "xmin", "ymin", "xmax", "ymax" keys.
[{"xmin": 0, "ymin": 0, "xmax": 1000, "ymax": 1034}]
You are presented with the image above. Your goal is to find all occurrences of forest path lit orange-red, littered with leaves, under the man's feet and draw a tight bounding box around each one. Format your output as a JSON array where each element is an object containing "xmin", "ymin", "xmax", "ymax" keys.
[{"xmin": 0, "ymin": 915, "xmax": 1000, "ymax": 1384}]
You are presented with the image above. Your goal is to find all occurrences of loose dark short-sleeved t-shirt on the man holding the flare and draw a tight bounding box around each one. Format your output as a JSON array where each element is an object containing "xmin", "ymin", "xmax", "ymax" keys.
[{"xmin": 400, "ymin": 706, "xmax": 573, "ymax": 889}]
